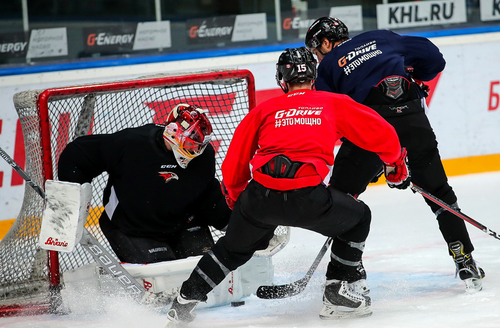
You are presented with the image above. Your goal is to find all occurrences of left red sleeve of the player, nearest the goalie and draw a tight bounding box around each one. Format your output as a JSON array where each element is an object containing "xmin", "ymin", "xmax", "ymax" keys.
[{"xmin": 221, "ymin": 107, "xmax": 260, "ymax": 201}]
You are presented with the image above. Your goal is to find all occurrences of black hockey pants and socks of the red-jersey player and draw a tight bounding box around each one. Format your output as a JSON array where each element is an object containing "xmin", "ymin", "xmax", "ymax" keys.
[{"xmin": 181, "ymin": 181, "xmax": 371, "ymax": 300}]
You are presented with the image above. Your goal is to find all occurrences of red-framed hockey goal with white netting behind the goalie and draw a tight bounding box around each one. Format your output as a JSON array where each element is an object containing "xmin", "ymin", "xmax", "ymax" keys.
[{"xmin": 0, "ymin": 70, "xmax": 255, "ymax": 316}]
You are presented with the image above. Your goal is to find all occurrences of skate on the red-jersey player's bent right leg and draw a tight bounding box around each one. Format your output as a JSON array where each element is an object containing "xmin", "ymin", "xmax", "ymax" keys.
[{"xmin": 319, "ymin": 280, "xmax": 372, "ymax": 320}]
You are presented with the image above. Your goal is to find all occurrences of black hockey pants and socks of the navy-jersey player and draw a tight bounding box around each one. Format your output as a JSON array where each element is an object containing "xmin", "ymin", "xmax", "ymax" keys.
[{"xmin": 330, "ymin": 110, "xmax": 474, "ymax": 254}]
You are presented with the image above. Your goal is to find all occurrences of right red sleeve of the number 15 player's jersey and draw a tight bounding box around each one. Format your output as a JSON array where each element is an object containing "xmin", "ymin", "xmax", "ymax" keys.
[{"xmin": 335, "ymin": 95, "xmax": 401, "ymax": 163}]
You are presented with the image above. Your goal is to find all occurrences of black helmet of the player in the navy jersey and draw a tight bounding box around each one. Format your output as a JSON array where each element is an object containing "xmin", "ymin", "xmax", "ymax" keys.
[{"xmin": 305, "ymin": 17, "xmax": 349, "ymax": 49}]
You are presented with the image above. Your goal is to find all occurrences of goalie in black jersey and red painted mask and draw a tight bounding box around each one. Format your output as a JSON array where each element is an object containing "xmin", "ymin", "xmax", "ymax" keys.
[{"xmin": 58, "ymin": 104, "xmax": 231, "ymax": 263}]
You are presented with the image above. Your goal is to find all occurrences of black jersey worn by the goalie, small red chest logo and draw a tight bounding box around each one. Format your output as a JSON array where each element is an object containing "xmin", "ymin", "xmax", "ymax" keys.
[{"xmin": 58, "ymin": 124, "xmax": 230, "ymax": 237}]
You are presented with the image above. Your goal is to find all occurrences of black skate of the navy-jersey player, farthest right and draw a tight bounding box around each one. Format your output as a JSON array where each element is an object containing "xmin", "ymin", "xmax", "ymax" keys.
[{"xmin": 450, "ymin": 241, "xmax": 485, "ymax": 294}]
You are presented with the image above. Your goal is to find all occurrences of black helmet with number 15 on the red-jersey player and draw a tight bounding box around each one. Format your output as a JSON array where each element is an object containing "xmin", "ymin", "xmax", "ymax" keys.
[{"xmin": 276, "ymin": 47, "xmax": 316, "ymax": 93}]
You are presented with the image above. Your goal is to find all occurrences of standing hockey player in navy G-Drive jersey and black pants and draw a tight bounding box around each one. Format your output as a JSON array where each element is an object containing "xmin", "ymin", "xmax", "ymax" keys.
[{"xmin": 305, "ymin": 17, "xmax": 484, "ymax": 292}]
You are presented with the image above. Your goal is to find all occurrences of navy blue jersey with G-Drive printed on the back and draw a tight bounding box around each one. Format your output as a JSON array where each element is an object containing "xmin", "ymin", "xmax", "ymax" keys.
[{"xmin": 315, "ymin": 30, "xmax": 446, "ymax": 103}]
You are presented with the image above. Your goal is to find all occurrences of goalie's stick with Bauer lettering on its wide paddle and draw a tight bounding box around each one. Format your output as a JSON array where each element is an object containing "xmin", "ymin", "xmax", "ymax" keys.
[{"xmin": 0, "ymin": 147, "xmax": 146, "ymax": 301}]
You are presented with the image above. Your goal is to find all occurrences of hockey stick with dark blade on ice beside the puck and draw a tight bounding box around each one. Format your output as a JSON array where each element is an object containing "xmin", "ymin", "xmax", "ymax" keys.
[{"xmin": 256, "ymin": 237, "xmax": 333, "ymax": 299}]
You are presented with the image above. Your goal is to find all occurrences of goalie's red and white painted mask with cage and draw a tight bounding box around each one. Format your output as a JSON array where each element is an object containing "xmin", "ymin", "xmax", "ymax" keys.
[{"xmin": 163, "ymin": 104, "xmax": 212, "ymax": 168}]
